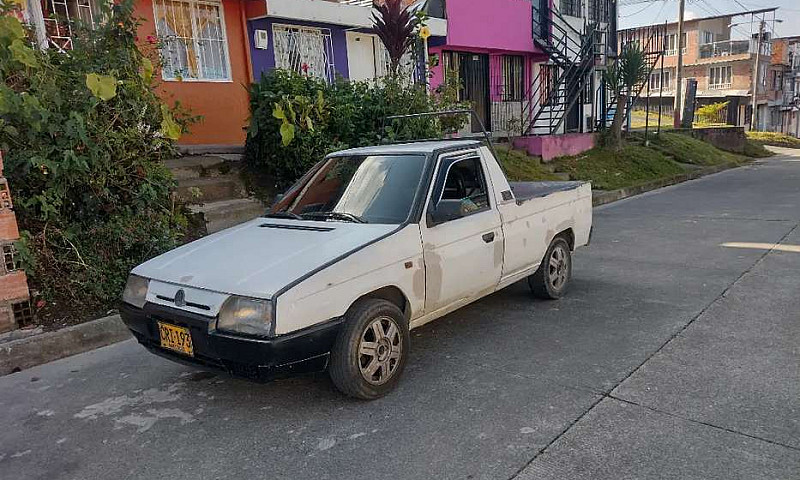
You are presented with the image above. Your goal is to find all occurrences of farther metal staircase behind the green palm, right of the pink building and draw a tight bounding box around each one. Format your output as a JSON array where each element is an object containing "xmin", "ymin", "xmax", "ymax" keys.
[{"xmin": 595, "ymin": 24, "xmax": 667, "ymax": 130}]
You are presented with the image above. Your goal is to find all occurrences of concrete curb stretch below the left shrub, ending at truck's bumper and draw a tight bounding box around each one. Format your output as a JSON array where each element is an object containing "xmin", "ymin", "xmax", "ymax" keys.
[{"xmin": 0, "ymin": 315, "xmax": 131, "ymax": 376}]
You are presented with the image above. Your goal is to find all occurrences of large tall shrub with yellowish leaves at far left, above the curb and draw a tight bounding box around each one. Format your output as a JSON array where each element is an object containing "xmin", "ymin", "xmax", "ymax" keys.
[{"xmin": 0, "ymin": 0, "xmax": 190, "ymax": 324}]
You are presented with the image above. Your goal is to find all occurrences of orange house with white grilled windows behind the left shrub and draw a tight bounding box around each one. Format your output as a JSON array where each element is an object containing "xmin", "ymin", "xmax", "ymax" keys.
[{"xmin": 23, "ymin": 0, "xmax": 253, "ymax": 148}]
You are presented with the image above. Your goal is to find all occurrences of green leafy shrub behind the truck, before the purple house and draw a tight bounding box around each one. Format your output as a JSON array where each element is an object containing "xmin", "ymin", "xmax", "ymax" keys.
[{"xmin": 245, "ymin": 70, "xmax": 463, "ymax": 188}]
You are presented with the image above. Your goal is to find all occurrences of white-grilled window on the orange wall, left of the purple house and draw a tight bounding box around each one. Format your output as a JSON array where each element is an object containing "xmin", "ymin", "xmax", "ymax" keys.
[{"xmin": 153, "ymin": 0, "xmax": 231, "ymax": 81}]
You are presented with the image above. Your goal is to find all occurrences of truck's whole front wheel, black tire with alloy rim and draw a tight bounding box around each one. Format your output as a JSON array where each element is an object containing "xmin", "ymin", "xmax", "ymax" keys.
[{"xmin": 328, "ymin": 299, "xmax": 411, "ymax": 400}]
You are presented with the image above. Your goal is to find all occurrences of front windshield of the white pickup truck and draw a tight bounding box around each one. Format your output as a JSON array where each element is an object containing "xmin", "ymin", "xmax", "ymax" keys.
[{"xmin": 272, "ymin": 155, "xmax": 425, "ymax": 224}]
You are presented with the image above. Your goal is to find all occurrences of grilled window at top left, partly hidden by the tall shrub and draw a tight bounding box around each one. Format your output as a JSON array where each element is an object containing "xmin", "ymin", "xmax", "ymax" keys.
[{"xmin": 41, "ymin": 0, "xmax": 100, "ymax": 51}]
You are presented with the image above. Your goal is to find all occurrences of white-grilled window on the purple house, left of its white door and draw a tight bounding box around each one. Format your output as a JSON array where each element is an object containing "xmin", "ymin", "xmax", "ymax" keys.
[{"xmin": 272, "ymin": 25, "xmax": 334, "ymax": 82}]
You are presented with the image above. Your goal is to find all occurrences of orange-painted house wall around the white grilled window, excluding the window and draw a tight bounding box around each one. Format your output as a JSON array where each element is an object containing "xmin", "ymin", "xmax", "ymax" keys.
[{"xmin": 135, "ymin": 0, "xmax": 251, "ymax": 146}]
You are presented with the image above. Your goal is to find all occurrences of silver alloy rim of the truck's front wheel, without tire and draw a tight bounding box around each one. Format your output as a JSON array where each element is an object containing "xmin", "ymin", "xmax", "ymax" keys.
[{"xmin": 358, "ymin": 316, "xmax": 403, "ymax": 385}]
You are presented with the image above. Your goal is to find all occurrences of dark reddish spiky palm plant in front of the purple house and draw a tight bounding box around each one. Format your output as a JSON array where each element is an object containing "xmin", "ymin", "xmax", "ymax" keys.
[{"xmin": 372, "ymin": 0, "xmax": 419, "ymax": 77}]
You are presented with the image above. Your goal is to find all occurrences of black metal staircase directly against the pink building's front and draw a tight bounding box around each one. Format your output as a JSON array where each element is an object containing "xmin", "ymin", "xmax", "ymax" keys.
[{"xmin": 522, "ymin": 2, "xmax": 604, "ymax": 135}]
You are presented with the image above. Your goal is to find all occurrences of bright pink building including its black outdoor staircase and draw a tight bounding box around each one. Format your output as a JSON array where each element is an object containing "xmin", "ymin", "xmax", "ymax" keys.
[{"xmin": 429, "ymin": 0, "xmax": 616, "ymax": 156}]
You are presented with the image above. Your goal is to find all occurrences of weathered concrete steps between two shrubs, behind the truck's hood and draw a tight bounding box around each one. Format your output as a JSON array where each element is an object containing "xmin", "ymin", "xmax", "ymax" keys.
[{"xmin": 165, "ymin": 151, "xmax": 266, "ymax": 233}]
